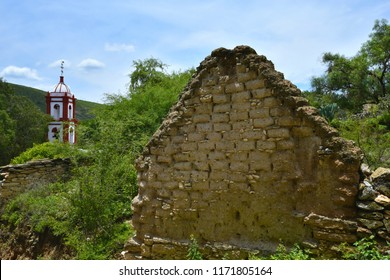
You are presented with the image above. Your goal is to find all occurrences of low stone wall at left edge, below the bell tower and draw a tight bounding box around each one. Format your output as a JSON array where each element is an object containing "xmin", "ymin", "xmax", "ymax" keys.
[{"xmin": 0, "ymin": 159, "xmax": 71, "ymax": 205}]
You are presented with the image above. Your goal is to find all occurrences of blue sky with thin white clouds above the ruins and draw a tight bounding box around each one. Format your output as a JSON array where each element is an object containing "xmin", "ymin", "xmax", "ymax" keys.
[{"xmin": 0, "ymin": 0, "xmax": 390, "ymax": 102}]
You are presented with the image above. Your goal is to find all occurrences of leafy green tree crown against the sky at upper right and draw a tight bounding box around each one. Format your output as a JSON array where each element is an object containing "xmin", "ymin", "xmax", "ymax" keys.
[{"xmin": 312, "ymin": 20, "xmax": 390, "ymax": 112}]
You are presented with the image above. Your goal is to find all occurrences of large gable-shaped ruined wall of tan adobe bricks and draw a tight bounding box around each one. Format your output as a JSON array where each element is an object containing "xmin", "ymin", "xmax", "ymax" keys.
[{"xmin": 126, "ymin": 46, "xmax": 361, "ymax": 259}]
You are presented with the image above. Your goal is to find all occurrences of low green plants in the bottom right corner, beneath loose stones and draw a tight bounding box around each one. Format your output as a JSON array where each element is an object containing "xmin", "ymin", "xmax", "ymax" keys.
[{"xmin": 339, "ymin": 235, "xmax": 390, "ymax": 260}]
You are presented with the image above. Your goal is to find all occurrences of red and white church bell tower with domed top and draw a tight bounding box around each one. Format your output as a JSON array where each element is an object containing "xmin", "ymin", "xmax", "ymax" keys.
[{"xmin": 46, "ymin": 61, "xmax": 77, "ymax": 144}]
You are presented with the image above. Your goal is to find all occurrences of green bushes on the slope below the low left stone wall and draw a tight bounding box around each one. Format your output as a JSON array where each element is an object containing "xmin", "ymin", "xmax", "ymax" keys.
[{"xmin": 1, "ymin": 181, "xmax": 131, "ymax": 259}]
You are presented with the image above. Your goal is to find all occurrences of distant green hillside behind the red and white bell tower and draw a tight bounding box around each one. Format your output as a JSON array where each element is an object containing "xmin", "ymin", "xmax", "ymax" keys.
[{"xmin": 9, "ymin": 83, "xmax": 104, "ymax": 121}]
